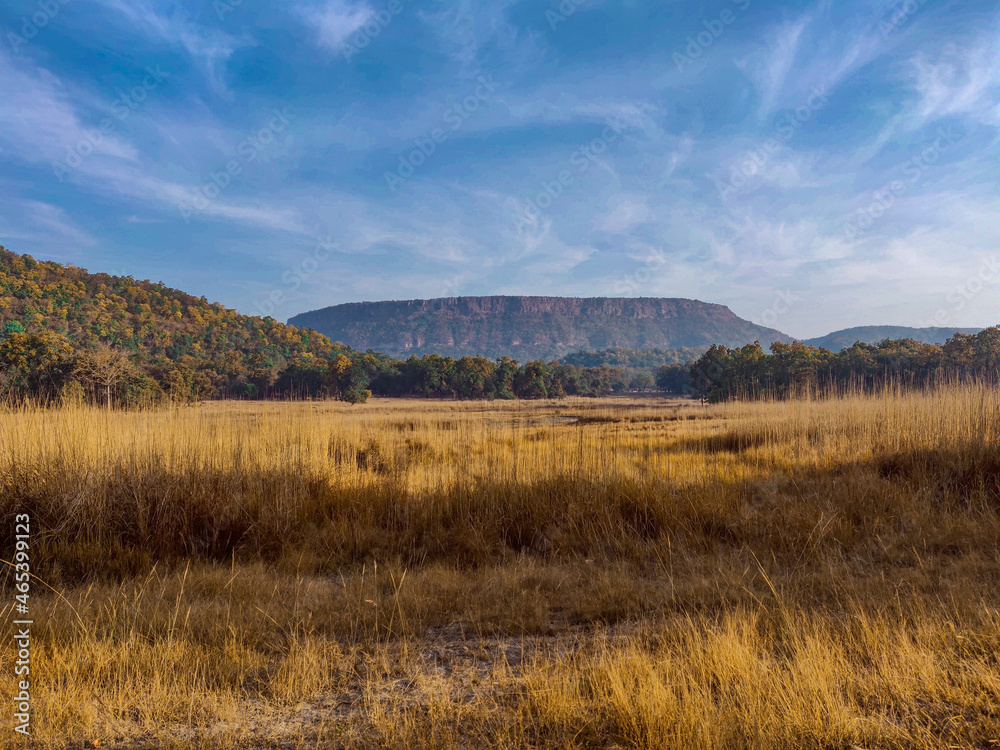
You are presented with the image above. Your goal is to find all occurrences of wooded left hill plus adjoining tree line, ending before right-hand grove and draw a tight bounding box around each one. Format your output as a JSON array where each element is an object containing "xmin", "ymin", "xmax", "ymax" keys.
[{"xmin": 0, "ymin": 248, "xmax": 672, "ymax": 406}]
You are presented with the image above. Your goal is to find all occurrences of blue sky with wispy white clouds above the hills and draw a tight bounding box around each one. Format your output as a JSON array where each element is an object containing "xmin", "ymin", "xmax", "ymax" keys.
[{"xmin": 0, "ymin": 0, "xmax": 1000, "ymax": 337}]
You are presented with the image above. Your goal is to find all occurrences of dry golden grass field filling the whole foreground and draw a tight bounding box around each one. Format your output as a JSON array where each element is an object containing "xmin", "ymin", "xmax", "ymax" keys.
[{"xmin": 0, "ymin": 386, "xmax": 1000, "ymax": 750}]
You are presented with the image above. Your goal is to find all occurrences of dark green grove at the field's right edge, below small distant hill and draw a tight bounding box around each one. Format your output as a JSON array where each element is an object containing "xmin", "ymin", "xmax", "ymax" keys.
[{"xmin": 690, "ymin": 334, "xmax": 1000, "ymax": 401}]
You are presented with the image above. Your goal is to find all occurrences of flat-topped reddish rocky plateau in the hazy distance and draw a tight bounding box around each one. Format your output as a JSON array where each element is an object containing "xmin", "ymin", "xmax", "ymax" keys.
[{"xmin": 288, "ymin": 297, "xmax": 791, "ymax": 361}]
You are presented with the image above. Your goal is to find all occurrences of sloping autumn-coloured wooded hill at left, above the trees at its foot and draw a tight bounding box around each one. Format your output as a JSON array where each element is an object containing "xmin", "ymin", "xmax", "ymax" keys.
[{"xmin": 0, "ymin": 247, "xmax": 345, "ymax": 395}]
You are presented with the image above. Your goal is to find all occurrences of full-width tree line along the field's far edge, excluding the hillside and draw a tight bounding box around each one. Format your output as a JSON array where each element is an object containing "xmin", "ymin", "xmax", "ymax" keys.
[{"xmin": 7, "ymin": 322, "xmax": 1000, "ymax": 408}]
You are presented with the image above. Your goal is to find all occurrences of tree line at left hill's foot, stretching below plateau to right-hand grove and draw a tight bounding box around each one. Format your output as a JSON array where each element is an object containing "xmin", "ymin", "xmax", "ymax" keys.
[{"xmin": 0, "ymin": 324, "xmax": 680, "ymax": 408}]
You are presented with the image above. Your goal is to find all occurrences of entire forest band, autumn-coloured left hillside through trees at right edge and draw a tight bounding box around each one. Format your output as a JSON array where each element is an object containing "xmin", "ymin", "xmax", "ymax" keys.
[{"xmin": 0, "ymin": 248, "xmax": 1000, "ymax": 407}]
